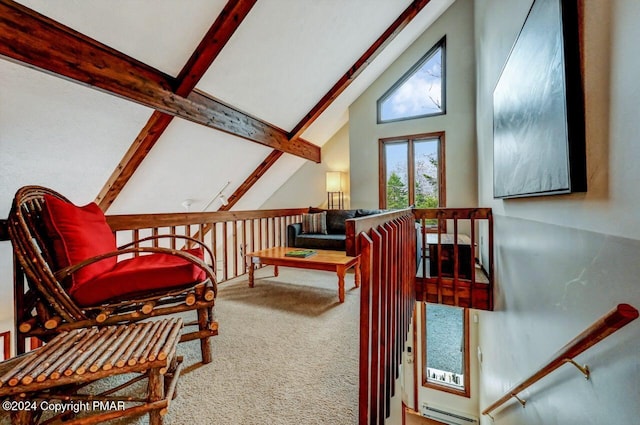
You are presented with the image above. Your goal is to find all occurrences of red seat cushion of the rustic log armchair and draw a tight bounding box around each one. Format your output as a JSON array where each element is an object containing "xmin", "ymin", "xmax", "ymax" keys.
[{"xmin": 70, "ymin": 249, "xmax": 206, "ymax": 306}]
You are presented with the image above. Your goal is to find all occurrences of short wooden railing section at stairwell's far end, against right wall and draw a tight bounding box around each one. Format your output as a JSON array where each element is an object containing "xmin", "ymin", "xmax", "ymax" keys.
[{"xmin": 413, "ymin": 208, "xmax": 493, "ymax": 310}]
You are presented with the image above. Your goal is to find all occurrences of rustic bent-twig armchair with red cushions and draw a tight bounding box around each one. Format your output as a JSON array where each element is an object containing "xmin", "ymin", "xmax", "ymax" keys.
[{"xmin": 8, "ymin": 186, "xmax": 218, "ymax": 363}]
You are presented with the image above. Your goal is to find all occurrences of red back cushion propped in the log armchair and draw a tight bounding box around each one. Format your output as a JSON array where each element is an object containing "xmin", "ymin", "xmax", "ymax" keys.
[{"xmin": 42, "ymin": 195, "xmax": 118, "ymax": 287}]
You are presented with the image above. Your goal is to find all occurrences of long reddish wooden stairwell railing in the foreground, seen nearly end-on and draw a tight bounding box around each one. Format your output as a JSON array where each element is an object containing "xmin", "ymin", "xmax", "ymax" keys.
[{"xmin": 347, "ymin": 210, "xmax": 416, "ymax": 425}]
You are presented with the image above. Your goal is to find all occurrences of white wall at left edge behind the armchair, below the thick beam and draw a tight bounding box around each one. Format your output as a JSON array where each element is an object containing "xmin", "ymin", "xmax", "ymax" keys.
[{"xmin": 0, "ymin": 60, "xmax": 151, "ymax": 350}]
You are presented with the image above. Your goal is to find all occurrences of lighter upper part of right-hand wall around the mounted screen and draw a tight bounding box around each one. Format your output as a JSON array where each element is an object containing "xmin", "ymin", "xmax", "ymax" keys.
[{"xmin": 476, "ymin": 0, "xmax": 640, "ymax": 238}]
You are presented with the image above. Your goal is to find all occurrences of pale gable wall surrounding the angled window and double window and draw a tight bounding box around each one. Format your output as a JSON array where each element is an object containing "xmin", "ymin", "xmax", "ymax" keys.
[{"xmin": 349, "ymin": 0, "xmax": 477, "ymax": 208}]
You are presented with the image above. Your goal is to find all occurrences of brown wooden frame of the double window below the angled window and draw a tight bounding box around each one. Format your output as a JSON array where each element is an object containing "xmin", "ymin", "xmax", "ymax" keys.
[{"xmin": 378, "ymin": 131, "xmax": 447, "ymax": 209}]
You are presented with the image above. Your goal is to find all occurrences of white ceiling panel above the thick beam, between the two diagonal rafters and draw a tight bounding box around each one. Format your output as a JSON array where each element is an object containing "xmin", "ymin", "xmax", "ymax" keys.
[{"xmin": 198, "ymin": 0, "xmax": 410, "ymax": 130}]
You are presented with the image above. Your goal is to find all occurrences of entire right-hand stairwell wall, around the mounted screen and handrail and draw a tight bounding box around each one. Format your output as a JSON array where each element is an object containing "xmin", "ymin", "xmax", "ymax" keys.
[{"xmin": 475, "ymin": 0, "xmax": 640, "ymax": 425}]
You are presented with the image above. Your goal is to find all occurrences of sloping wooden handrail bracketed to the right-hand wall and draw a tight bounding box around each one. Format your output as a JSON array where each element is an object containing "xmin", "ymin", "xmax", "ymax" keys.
[{"xmin": 482, "ymin": 304, "xmax": 638, "ymax": 416}]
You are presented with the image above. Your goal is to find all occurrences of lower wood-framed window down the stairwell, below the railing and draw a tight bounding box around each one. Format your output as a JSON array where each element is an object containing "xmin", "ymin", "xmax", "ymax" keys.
[{"xmin": 422, "ymin": 303, "xmax": 471, "ymax": 397}]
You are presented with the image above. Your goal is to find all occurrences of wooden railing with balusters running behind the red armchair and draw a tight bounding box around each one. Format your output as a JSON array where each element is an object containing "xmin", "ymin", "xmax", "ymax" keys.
[{"xmin": 107, "ymin": 208, "xmax": 308, "ymax": 282}]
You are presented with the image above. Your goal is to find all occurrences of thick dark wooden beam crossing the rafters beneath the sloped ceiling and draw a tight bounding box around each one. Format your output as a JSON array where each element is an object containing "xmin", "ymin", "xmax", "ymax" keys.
[{"xmin": 0, "ymin": 0, "xmax": 320, "ymax": 166}]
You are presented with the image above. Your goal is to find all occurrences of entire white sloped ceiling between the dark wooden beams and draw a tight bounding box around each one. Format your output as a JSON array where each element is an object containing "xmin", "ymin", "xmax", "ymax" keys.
[{"xmin": 0, "ymin": 0, "xmax": 453, "ymax": 216}]
